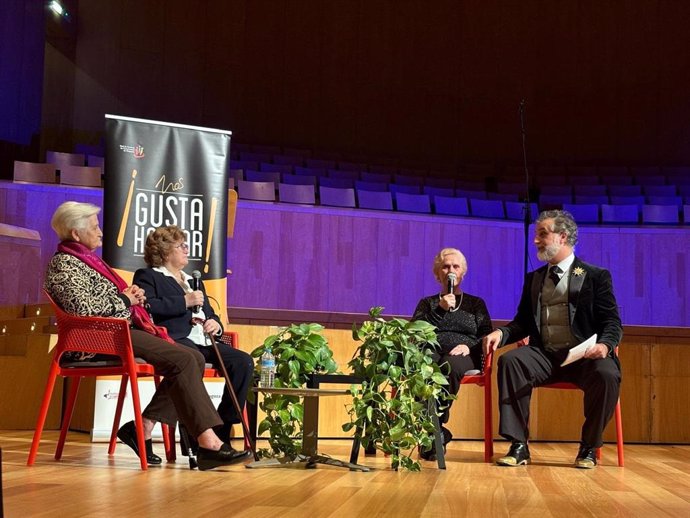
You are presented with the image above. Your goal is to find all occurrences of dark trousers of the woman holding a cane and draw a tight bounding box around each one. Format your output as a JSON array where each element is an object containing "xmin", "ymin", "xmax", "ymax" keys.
[{"xmin": 177, "ymin": 338, "xmax": 254, "ymax": 424}]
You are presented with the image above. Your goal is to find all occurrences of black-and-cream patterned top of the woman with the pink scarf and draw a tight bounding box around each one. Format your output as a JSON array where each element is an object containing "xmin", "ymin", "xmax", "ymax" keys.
[{"xmin": 43, "ymin": 252, "xmax": 131, "ymax": 361}]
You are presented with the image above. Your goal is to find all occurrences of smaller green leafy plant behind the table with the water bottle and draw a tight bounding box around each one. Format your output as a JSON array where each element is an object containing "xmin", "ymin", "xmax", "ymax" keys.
[{"xmin": 252, "ymin": 324, "xmax": 337, "ymax": 460}]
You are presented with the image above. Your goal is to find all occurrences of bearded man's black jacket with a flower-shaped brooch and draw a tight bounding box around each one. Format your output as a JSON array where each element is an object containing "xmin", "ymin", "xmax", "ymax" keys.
[{"xmin": 500, "ymin": 257, "xmax": 623, "ymax": 361}]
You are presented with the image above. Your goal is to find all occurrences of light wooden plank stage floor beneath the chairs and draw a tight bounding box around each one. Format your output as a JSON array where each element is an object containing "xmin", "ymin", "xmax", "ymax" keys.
[{"xmin": 0, "ymin": 431, "xmax": 690, "ymax": 518}]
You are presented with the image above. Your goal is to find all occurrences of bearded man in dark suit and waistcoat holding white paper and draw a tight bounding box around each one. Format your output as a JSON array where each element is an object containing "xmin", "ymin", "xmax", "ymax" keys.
[{"xmin": 483, "ymin": 210, "xmax": 623, "ymax": 469}]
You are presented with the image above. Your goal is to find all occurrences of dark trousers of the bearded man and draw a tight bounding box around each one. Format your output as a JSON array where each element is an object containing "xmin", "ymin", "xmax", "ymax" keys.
[{"xmin": 498, "ymin": 346, "xmax": 621, "ymax": 448}]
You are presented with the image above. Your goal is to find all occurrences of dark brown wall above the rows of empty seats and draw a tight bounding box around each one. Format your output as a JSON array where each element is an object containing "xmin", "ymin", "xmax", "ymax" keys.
[{"xmin": 37, "ymin": 0, "xmax": 690, "ymax": 169}]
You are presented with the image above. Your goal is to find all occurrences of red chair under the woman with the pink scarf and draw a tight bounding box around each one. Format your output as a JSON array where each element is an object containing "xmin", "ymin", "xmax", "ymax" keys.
[{"xmin": 27, "ymin": 296, "xmax": 170, "ymax": 470}]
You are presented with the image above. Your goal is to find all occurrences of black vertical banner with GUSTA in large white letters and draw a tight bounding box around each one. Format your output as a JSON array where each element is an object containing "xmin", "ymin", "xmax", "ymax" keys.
[{"xmin": 103, "ymin": 115, "xmax": 231, "ymax": 322}]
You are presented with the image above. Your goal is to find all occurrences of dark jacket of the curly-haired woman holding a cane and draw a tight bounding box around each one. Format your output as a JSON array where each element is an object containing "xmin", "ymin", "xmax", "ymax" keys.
[{"xmin": 133, "ymin": 268, "xmax": 223, "ymax": 346}]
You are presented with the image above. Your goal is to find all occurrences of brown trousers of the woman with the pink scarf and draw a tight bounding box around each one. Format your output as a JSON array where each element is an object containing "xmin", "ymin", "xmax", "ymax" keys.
[{"xmin": 131, "ymin": 329, "xmax": 222, "ymax": 437}]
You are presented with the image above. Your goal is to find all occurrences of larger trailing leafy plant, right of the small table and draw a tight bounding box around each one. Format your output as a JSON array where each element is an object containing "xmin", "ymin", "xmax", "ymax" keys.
[{"xmin": 343, "ymin": 307, "xmax": 454, "ymax": 471}]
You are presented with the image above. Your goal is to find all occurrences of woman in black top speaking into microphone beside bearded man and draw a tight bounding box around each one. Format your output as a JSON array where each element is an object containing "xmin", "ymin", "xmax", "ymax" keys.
[{"xmin": 412, "ymin": 248, "xmax": 493, "ymax": 460}]
